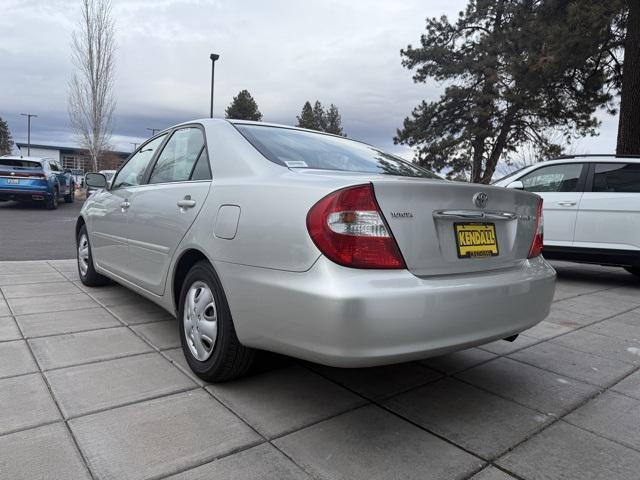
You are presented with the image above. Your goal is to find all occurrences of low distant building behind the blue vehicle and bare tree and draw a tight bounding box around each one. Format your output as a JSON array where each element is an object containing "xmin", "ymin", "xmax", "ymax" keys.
[{"xmin": 16, "ymin": 142, "xmax": 131, "ymax": 172}]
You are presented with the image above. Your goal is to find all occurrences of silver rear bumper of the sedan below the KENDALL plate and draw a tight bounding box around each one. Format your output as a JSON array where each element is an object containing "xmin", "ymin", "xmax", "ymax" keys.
[{"xmin": 216, "ymin": 257, "xmax": 555, "ymax": 367}]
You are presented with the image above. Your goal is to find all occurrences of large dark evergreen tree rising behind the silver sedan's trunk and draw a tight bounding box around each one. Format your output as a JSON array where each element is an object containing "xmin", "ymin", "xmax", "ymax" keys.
[{"xmin": 394, "ymin": 0, "xmax": 616, "ymax": 183}]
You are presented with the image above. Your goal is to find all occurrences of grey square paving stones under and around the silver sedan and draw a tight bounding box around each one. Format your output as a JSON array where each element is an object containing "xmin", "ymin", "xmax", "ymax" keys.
[{"xmin": 0, "ymin": 260, "xmax": 640, "ymax": 480}]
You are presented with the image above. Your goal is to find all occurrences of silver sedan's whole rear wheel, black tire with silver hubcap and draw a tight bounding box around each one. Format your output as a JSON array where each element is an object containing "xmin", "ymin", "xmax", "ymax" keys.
[{"xmin": 178, "ymin": 261, "xmax": 255, "ymax": 382}]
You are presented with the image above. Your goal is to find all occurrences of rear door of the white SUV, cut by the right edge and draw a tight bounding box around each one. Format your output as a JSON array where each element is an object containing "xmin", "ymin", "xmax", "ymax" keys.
[{"xmin": 574, "ymin": 161, "xmax": 640, "ymax": 250}]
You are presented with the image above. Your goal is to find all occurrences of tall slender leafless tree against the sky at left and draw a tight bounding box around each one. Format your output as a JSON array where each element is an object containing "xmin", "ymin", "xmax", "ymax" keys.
[{"xmin": 68, "ymin": 0, "xmax": 116, "ymax": 170}]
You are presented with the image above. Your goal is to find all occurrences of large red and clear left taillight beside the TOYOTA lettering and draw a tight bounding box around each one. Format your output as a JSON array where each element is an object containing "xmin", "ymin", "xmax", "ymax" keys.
[{"xmin": 307, "ymin": 184, "xmax": 406, "ymax": 269}]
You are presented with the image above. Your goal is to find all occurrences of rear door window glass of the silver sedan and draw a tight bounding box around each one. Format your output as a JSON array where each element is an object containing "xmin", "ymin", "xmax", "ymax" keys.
[{"xmin": 149, "ymin": 127, "xmax": 204, "ymax": 183}]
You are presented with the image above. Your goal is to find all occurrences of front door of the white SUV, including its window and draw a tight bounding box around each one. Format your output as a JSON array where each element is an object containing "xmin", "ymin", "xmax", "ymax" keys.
[{"xmin": 519, "ymin": 163, "xmax": 586, "ymax": 246}]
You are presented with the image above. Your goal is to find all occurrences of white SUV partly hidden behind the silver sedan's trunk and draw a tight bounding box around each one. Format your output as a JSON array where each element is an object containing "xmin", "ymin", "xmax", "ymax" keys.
[{"xmin": 494, "ymin": 155, "xmax": 640, "ymax": 276}]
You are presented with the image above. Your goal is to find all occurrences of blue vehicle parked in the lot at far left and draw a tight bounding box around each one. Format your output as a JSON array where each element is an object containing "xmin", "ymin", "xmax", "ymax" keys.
[{"xmin": 0, "ymin": 155, "xmax": 75, "ymax": 210}]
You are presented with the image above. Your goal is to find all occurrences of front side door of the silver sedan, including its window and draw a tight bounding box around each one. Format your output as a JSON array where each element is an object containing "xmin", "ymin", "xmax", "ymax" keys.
[{"xmin": 87, "ymin": 134, "xmax": 166, "ymax": 278}]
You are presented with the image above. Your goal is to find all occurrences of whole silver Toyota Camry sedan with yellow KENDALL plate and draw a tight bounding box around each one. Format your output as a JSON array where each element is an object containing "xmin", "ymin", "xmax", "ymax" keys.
[{"xmin": 76, "ymin": 119, "xmax": 555, "ymax": 381}]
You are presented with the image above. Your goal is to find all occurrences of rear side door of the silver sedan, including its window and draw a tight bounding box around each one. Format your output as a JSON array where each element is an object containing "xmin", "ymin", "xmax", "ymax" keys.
[{"xmin": 128, "ymin": 125, "xmax": 213, "ymax": 295}]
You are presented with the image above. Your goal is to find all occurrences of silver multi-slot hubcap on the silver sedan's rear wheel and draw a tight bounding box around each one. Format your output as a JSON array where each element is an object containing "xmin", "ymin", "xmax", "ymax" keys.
[{"xmin": 182, "ymin": 281, "xmax": 218, "ymax": 362}]
